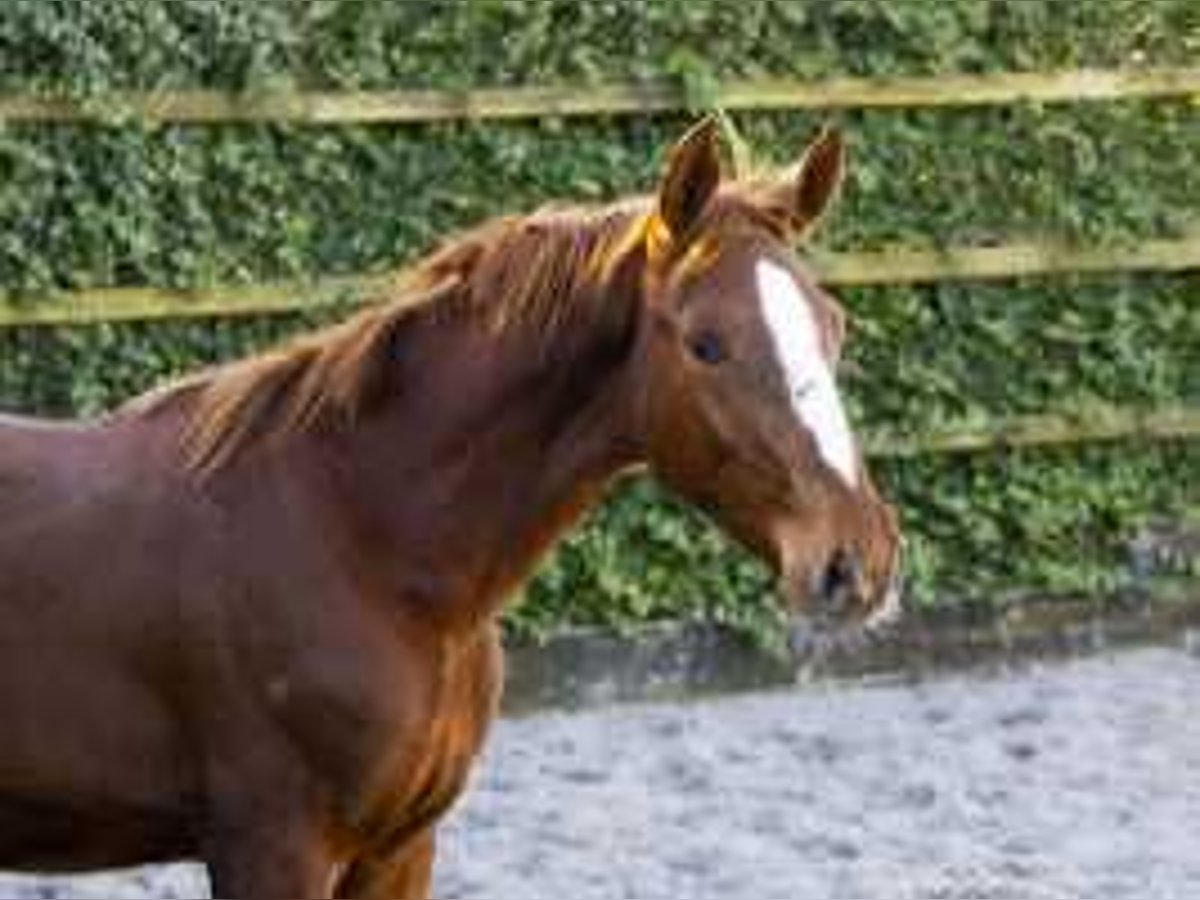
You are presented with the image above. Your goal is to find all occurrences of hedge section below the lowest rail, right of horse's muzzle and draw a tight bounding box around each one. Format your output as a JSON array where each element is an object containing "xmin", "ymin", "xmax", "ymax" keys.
[{"xmin": 880, "ymin": 442, "xmax": 1200, "ymax": 604}]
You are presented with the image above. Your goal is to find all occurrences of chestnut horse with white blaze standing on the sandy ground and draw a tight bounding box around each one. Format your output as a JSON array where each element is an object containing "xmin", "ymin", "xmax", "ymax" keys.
[{"xmin": 0, "ymin": 121, "xmax": 899, "ymax": 898}]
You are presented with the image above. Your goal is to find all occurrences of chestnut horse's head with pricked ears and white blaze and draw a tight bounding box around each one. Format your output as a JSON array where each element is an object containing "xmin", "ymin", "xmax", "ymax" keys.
[{"xmin": 636, "ymin": 121, "xmax": 900, "ymax": 652}]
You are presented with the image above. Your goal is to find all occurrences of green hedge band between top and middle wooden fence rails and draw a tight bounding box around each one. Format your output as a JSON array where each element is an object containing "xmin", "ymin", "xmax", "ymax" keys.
[{"xmin": 0, "ymin": 102, "xmax": 1200, "ymax": 294}]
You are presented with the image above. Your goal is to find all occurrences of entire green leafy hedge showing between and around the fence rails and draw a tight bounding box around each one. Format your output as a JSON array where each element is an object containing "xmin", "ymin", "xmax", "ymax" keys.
[{"xmin": 0, "ymin": 0, "xmax": 1200, "ymax": 631}]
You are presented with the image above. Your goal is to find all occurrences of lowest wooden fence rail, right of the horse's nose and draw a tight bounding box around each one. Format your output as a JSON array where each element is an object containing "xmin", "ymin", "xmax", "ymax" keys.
[{"xmin": 866, "ymin": 407, "xmax": 1200, "ymax": 458}]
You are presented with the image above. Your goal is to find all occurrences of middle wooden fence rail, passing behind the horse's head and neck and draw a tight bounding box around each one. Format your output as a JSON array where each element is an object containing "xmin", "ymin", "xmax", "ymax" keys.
[{"xmin": 0, "ymin": 234, "xmax": 1200, "ymax": 328}]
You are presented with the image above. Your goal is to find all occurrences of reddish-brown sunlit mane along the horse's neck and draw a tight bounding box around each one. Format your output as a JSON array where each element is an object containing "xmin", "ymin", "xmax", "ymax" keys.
[{"xmin": 126, "ymin": 200, "xmax": 650, "ymax": 473}]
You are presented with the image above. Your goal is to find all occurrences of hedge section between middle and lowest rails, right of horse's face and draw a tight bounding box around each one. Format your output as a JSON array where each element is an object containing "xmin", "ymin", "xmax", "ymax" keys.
[{"xmin": 845, "ymin": 275, "xmax": 1200, "ymax": 434}]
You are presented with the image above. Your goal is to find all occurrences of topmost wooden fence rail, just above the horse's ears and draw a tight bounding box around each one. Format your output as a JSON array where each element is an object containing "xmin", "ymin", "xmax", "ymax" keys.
[{"xmin": 0, "ymin": 67, "xmax": 1200, "ymax": 125}]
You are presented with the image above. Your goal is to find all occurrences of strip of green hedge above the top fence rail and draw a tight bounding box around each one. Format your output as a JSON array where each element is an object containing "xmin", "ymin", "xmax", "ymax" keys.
[{"xmin": 0, "ymin": 0, "xmax": 1200, "ymax": 95}]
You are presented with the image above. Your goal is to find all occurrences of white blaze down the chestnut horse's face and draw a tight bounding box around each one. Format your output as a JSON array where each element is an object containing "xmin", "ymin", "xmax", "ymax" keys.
[{"xmin": 755, "ymin": 259, "xmax": 858, "ymax": 487}]
